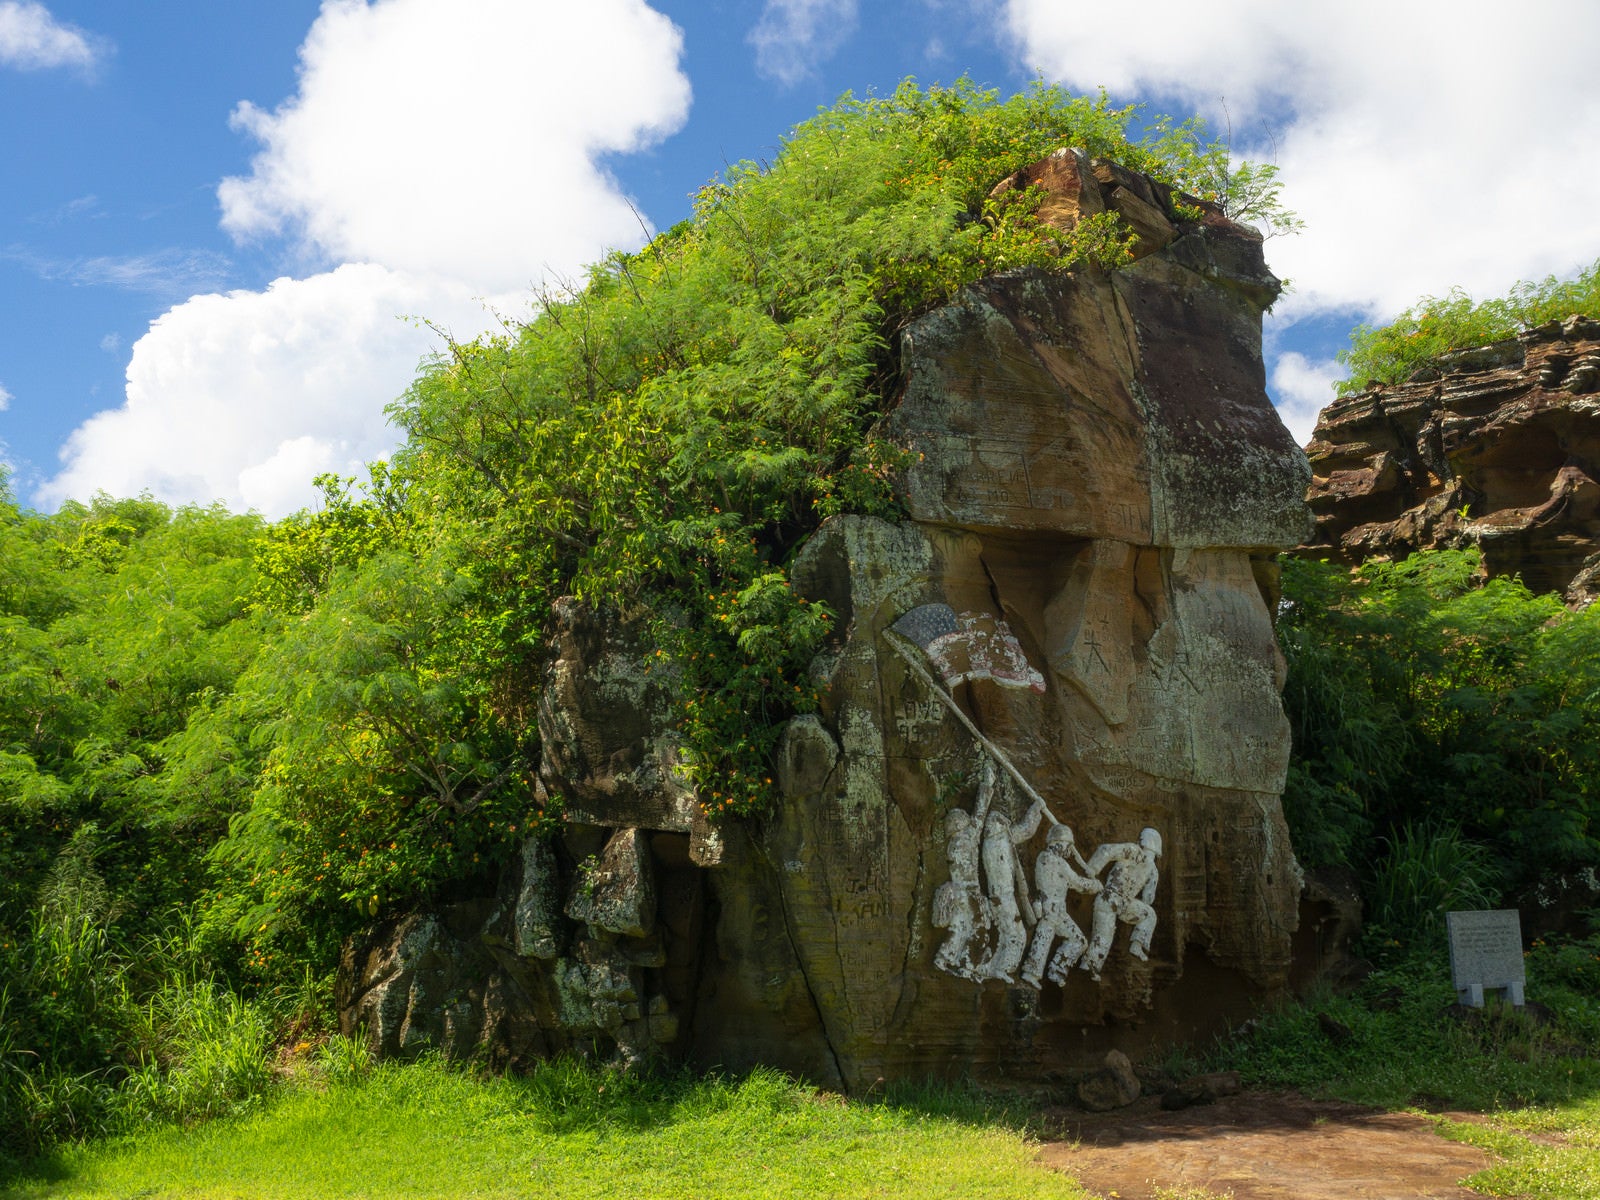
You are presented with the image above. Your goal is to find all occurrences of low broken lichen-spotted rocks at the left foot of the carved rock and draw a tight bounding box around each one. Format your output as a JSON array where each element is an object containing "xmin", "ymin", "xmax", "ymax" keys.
[{"xmin": 338, "ymin": 826, "xmax": 706, "ymax": 1067}]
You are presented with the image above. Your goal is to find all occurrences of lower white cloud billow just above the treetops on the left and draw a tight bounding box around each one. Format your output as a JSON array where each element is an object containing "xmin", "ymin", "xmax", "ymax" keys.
[{"xmin": 40, "ymin": 264, "xmax": 482, "ymax": 514}]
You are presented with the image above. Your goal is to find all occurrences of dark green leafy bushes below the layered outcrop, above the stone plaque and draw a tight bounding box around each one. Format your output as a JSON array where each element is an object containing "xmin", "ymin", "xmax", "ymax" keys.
[{"xmin": 1280, "ymin": 550, "xmax": 1600, "ymax": 886}]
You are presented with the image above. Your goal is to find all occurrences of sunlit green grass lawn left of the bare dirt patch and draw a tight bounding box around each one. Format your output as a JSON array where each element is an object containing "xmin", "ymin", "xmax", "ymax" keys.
[{"xmin": 0, "ymin": 1064, "xmax": 1088, "ymax": 1200}]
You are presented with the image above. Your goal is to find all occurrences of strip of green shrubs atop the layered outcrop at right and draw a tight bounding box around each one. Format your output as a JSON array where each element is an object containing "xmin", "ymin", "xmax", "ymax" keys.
[{"xmin": 1336, "ymin": 259, "xmax": 1600, "ymax": 395}]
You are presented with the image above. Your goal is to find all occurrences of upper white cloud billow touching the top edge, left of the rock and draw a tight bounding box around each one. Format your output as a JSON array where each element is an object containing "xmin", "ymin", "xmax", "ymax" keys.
[{"xmin": 218, "ymin": 0, "xmax": 690, "ymax": 291}]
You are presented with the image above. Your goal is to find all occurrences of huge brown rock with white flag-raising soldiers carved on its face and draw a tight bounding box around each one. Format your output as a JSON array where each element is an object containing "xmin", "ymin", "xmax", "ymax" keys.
[{"xmin": 341, "ymin": 150, "xmax": 1309, "ymax": 1088}]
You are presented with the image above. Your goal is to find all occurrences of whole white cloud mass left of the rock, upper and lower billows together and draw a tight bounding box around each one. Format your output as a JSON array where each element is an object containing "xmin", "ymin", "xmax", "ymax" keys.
[{"xmin": 48, "ymin": 0, "xmax": 690, "ymax": 517}]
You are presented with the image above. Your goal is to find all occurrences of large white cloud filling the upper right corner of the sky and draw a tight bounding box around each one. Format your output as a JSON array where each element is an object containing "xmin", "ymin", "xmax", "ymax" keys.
[{"xmin": 1006, "ymin": 0, "xmax": 1600, "ymax": 422}]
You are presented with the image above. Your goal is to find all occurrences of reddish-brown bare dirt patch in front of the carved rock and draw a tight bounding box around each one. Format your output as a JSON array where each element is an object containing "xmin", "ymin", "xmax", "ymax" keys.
[{"xmin": 1038, "ymin": 1093, "xmax": 1493, "ymax": 1200}]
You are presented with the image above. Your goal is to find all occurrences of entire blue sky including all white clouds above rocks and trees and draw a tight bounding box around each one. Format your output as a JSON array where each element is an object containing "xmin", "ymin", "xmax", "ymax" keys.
[{"xmin": 0, "ymin": 0, "xmax": 1600, "ymax": 515}]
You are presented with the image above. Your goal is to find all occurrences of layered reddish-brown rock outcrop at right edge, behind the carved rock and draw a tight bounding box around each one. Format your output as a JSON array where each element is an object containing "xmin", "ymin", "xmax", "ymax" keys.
[{"xmin": 1304, "ymin": 317, "xmax": 1600, "ymax": 603}]
